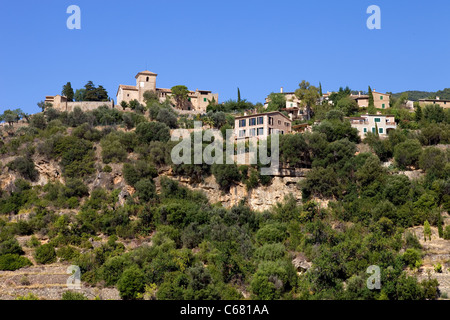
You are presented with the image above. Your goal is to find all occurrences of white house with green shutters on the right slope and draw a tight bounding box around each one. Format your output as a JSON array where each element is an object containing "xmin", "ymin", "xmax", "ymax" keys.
[{"xmin": 346, "ymin": 114, "xmax": 397, "ymax": 138}]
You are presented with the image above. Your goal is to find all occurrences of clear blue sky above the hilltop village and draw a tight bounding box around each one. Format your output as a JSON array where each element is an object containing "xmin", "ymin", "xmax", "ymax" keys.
[{"xmin": 0, "ymin": 0, "xmax": 450, "ymax": 113}]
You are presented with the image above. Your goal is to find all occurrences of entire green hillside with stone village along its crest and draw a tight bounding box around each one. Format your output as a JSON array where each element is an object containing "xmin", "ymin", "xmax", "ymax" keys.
[{"xmin": 0, "ymin": 70, "xmax": 450, "ymax": 300}]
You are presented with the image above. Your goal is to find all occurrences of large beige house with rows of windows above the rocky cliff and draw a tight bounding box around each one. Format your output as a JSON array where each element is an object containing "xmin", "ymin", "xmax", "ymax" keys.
[{"xmin": 234, "ymin": 111, "xmax": 292, "ymax": 140}]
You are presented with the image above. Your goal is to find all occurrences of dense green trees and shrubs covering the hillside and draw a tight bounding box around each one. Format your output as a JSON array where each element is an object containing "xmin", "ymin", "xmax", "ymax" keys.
[{"xmin": 0, "ymin": 83, "xmax": 450, "ymax": 299}]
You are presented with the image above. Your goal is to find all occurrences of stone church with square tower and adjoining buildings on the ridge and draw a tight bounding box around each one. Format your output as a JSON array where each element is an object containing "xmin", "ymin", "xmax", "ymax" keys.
[{"xmin": 116, "ymin": 70, "xmax": 219, "ymax": 112}]
